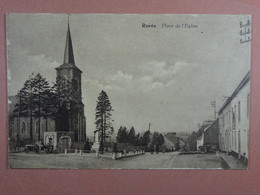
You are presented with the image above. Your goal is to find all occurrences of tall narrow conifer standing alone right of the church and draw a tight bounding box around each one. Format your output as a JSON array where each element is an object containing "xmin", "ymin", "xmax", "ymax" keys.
[{"xmin": 95, "ymin": 90, "xmax": 113, "ymax": 150}]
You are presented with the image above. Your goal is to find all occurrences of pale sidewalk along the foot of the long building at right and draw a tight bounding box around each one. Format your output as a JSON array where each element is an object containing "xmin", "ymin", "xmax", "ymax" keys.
[{"xmin": 216, "ymin": 152, "xmax": 248, "ymax": 169}]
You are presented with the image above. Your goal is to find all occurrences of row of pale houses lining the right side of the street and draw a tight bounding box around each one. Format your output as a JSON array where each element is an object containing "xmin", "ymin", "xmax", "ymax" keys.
[{"xmin": 197, "ymin": 72, "xmax": 250, "ymax": 159}]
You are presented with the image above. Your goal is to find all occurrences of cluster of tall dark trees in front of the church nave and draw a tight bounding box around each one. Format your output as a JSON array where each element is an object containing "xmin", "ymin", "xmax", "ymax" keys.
[{"xmin": 10, "ymin": 73, "xmax": 74, "ymax": 140}]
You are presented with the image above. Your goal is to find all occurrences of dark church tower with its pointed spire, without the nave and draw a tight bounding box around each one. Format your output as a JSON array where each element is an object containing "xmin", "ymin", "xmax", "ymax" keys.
[{"xmin": 56, "ymin": 17, "xmax": 86, "ymax": 142}]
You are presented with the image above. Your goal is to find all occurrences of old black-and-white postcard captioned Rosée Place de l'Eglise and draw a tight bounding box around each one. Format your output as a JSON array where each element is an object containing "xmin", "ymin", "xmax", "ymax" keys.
[{"xmin": 6, "ymin": 13, "xmax": 252, "ymax": 169}]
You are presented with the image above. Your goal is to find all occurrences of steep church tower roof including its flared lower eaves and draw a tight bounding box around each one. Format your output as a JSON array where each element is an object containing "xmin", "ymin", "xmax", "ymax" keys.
[{"xmin": 56, "ymin": 23, "xmax": 82, "ymax": 72}]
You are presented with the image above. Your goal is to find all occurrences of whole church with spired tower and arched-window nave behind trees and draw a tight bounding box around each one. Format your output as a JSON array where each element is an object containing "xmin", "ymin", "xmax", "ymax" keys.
[{"xmin": 8, "ymin": 19, "xmax": 86, "ymax": 152}]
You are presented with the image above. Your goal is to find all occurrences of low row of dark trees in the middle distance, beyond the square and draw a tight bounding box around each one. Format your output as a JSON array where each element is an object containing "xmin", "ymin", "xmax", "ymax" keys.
[{"xmin": 116, "ymin": 126, "xmax": 164, "ymax": 146}]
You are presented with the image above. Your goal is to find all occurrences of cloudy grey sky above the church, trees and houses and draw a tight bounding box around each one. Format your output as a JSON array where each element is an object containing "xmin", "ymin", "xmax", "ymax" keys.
[{"xmin": 6, "ymin": 14, "xmax": 251, "ymax": 136}]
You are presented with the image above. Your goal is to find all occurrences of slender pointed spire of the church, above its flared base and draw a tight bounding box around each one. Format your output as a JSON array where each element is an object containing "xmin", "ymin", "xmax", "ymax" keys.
[{"xmin": 63, "ymin": 14, "xmax": 75, "ymax": 65}]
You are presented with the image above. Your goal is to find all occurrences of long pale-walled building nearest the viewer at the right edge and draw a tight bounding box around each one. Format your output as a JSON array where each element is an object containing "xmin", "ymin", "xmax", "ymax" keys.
[{"xmin": 218, "ymin": 72, "xmax": 250, "ymax": 159}]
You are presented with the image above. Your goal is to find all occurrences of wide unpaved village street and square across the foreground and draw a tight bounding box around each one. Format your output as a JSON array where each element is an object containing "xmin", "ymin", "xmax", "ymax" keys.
[{"xmin": 9, "ymin": 152, "xmax": 227, "ymax": 169}]
